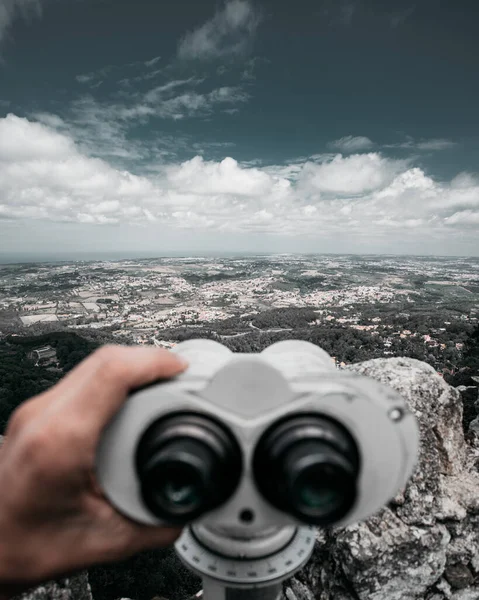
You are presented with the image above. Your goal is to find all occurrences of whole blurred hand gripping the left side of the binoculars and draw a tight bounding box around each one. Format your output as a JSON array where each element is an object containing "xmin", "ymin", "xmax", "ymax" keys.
[{"xmin": 0, "ymin": 345, "xmax": 186, "ymax": 600}]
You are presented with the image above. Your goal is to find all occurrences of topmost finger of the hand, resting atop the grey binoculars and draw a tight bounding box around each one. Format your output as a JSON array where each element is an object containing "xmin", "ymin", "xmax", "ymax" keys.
[{"xmin": 50, "ymin": 345, "xmax": 187, "ymax": 432}]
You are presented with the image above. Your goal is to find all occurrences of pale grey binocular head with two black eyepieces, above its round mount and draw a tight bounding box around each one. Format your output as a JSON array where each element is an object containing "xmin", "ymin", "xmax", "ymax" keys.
[{"xmin": 96, "ymin": 339, "xmax": 419, "ymax": 541}]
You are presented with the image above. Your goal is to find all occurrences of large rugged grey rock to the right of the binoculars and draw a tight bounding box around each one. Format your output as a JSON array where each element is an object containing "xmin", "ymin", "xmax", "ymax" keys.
[{"xmin": 283, "ymin": 358, "xmax": 479, "ymax": 600}]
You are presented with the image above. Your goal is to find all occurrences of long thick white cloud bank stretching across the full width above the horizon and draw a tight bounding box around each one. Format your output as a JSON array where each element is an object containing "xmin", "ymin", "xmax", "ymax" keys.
[{"xmin": 0, "ymin": 114, "xmax": 479, "ymax": 248}]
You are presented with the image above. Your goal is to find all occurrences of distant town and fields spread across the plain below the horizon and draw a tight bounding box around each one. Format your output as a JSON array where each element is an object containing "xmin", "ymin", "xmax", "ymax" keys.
[{"xmin": 0, "ymin": 255, "xmax": 479, "ymax": 380}]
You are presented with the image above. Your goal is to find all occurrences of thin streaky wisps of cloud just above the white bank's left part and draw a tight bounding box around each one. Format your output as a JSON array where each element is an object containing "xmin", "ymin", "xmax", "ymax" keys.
[{"xmin": 29, "ymin": 77, "xmax": 249, "ymax": 168}]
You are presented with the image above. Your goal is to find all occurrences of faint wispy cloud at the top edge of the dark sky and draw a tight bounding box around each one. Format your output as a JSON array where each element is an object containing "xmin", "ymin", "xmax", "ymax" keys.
[{"xmin": 178, "ymin": 0, "xmax": 260, "ymax": 60}]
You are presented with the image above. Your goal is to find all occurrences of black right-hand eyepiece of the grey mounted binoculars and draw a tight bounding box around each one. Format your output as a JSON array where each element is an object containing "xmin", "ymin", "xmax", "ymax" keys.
[{"xmin": 253, "ymin": 415, "xmax": 359, "ymax": 526}]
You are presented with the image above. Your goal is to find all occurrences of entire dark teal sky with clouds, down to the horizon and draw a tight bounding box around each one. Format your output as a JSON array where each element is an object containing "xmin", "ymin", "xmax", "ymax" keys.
[{"xmin": 0, "ymin": 0, "xmax": 479, "ymax": 258}]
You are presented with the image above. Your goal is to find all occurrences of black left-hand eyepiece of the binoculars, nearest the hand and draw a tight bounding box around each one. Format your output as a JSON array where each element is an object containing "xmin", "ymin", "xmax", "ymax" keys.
[{"xmin": 136, "ymin": 413, "xmax": 246, "ymax": 524}]
